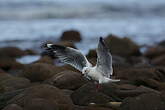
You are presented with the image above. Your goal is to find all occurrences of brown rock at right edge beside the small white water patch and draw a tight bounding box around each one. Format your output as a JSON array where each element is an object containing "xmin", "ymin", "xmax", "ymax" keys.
[{"xmin": 144, "ymin": 46, "xmax": 165, "ymax": 59}]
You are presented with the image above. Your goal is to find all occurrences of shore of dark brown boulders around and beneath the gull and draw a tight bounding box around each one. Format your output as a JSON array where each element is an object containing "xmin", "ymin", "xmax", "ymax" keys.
[{"xmin": 0, "ymin": 30, "xmax": 165, "ymax": 110}]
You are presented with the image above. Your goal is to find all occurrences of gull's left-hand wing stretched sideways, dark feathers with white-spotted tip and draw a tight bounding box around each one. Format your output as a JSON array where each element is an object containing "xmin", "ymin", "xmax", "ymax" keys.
[{"xmin": 46, "ymin": 44, "xmax": 92, "ymax": 71}]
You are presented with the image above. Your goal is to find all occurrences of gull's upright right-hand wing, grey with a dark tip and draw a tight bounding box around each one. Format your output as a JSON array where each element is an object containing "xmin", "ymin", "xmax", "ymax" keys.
[{"xmin": 96, "ymin": 37, "xmax": 113, "ymax": 78}]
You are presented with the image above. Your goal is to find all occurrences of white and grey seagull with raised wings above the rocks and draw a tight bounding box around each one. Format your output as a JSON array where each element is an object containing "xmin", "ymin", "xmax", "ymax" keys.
[{"xmin": 45, "ymin": 37, "xmax": 120, "ymax": 88}]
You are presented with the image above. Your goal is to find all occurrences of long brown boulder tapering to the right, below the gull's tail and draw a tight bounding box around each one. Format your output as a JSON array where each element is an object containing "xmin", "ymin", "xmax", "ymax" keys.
[{"xmin": 99, "ymin": 83, "xmax": 159, "ymax": 101}]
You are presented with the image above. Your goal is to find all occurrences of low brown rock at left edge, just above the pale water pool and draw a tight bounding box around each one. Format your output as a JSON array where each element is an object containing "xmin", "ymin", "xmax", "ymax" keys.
[{"xmin": 0, "ymin": 47, "xmax": 26, "ymax": 57}]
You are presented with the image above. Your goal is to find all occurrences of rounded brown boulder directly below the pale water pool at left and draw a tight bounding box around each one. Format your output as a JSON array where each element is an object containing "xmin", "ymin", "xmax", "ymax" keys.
[{"xmin": 20, "ymin": 63, "xmax": 58, "ymax": 82}]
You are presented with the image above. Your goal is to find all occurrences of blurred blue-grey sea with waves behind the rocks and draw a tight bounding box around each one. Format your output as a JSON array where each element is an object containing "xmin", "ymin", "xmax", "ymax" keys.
[{"xmin": 0, "ymin": 0, "xmax": 165, "ymax": 51}]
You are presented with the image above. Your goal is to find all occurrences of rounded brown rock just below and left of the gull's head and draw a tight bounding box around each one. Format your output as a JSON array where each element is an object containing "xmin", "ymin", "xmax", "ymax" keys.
[{"xmin": 46, "ymin": 70, "xmax": 86, "ymax": 90}]
